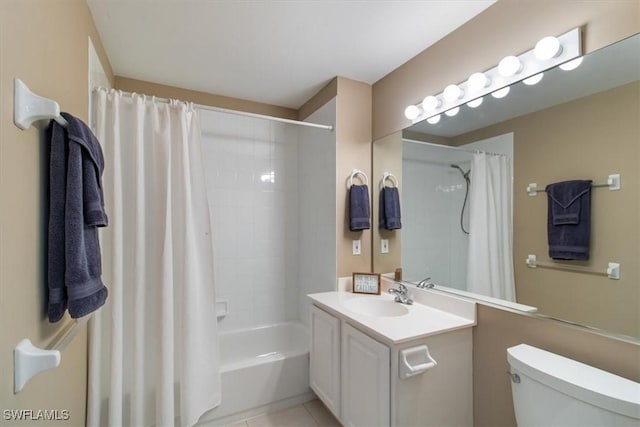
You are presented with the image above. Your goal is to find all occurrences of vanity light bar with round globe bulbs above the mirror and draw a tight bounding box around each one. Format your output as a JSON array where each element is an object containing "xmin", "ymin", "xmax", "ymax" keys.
[{"xmin": 405, "ymin": 28, "xmax": 582, "ymax": 124}]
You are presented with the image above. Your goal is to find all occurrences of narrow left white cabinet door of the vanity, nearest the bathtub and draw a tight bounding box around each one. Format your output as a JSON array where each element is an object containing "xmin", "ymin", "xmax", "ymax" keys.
[{"xmin": 309, "ymin": 306, "xmax": 340, "ymax": 418}]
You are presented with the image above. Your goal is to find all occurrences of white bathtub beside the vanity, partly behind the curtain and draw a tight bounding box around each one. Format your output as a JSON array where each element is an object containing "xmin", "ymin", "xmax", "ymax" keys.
[{"xmin": 198, "ymin": 322, "xmax": 314, "ymax": 426}]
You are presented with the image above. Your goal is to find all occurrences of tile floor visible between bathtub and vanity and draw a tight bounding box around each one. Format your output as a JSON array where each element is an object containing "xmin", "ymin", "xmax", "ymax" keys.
[{"xmin": 227, "ymin": 399, "xmax": 341, "ymax": 427}]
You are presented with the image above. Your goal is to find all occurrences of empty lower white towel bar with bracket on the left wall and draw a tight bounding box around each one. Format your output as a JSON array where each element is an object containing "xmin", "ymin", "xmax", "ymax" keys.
[{"xmin": 13, "ymin": 315, "xmax": 92, "ymax": 394}]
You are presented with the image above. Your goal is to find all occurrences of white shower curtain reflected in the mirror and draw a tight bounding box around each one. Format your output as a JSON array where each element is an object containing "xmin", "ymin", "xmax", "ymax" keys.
[{"xmin": 467, "ymin": 153, "xmax": 516, "ymax": 301}]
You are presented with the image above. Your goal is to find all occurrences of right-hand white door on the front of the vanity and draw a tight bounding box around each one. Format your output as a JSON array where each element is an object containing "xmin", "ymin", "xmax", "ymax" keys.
[{"xmin": 341, "ymin": 323, "xmax": 391, "ymax": 427}]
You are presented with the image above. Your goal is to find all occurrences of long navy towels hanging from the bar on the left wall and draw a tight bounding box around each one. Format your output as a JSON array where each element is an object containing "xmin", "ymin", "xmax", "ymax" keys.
[{"xmin": 47, "ymin": 113, "xmax": 108, "ymax": 322}]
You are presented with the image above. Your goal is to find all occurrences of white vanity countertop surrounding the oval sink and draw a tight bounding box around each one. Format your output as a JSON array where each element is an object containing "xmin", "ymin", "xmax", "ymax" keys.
[{"xmin": 308, "ymin": 292, "xmax": 476, "ymax": 344}]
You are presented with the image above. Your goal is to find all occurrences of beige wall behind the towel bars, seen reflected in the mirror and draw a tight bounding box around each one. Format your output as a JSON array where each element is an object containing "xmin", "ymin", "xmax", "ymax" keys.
[{"xmin": 454, "ymin": 82, "xmax": 640, "ymax": 338}]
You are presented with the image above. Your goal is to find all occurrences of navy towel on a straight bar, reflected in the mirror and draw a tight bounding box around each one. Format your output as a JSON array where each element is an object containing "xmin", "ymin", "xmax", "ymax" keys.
[{"xmin": 546, "ymin": 180, "xmax": 591, "ymax": 260}]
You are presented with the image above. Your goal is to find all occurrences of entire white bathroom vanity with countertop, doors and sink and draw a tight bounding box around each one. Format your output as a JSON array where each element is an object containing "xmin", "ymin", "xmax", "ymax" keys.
[{"xmin": 309, "ymin": 285, "xmax": 476, "ymax": 427}]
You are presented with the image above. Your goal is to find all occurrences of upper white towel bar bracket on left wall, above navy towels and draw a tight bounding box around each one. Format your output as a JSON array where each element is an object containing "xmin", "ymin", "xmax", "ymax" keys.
[{"xmin": 13, "ymin": 79, "xmax": 68, "ymax": 130}]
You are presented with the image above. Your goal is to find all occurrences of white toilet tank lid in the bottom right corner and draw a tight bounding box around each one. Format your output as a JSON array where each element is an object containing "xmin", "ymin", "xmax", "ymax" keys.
[{"xmin": 507, "ymin": 344, "xmax": 640, "ymax": 419}]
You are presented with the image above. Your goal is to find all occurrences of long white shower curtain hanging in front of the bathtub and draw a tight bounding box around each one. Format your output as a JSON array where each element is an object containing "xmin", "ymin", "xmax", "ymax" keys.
[{"xmin": 87, "ymin": 90, "xmax": 220, "ymax": 426}]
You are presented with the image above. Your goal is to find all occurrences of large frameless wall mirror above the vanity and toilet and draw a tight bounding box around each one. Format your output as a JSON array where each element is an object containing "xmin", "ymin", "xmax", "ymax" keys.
[{"xmin": 373, "ymin": 34, "xmax": 640, "ymax": 340}]
